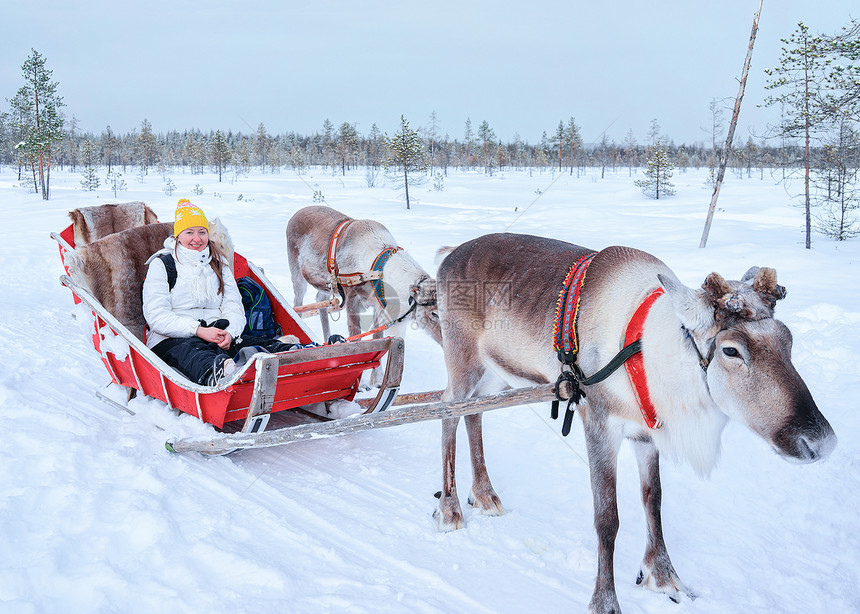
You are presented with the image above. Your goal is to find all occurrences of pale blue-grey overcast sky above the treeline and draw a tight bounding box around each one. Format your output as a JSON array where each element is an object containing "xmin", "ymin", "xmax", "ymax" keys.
[{"xmin": 0, "ymin": 0, "xmax": 860, "ymax": 144}]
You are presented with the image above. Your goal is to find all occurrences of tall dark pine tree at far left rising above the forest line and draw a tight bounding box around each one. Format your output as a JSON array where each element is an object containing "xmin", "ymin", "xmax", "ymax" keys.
[{"xmin": 15, "ymin": 49, "xmax": 65, "ymax": 200}]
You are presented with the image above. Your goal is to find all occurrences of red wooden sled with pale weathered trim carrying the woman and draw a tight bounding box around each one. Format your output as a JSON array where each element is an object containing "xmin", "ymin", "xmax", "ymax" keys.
[{"xmin": 51, "ymin": 203, "xmax": 403, "ymax": 453}]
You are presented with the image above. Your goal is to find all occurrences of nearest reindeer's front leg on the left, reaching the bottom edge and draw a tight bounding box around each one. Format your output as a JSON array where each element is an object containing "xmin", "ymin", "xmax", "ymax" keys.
[{"xmin": 584, "ymin": 412, "xmax": 621, "ymax": 614}]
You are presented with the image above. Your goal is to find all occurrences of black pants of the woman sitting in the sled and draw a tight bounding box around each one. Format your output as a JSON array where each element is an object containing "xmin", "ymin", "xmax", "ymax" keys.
[{"xmin": 152, "ymin": 337, "xmax": 295, "ymax": 386}]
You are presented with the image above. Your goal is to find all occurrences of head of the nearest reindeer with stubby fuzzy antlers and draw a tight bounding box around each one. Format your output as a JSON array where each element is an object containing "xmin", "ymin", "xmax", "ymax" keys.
[{"xmin": 660, "ymin": 267, "xmax": 836, "ymax": 462}]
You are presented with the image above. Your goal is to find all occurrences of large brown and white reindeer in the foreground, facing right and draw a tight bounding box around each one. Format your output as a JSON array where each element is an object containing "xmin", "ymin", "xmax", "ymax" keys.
[{"xmin": 434, "ymin": 234, "xmax": 836, "ymax": 613}]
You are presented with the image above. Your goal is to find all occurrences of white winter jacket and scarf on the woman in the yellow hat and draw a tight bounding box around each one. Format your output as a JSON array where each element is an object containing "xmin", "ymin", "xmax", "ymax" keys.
[{"xmin": 143, "ymin": 245, "xmax": 245, "ymax": 347}]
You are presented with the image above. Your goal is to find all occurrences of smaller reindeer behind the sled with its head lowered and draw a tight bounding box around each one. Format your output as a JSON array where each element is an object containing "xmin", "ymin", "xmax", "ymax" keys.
[{"xmin": 287, "ymin": 206, "xmax": 442, "ymax": 383}]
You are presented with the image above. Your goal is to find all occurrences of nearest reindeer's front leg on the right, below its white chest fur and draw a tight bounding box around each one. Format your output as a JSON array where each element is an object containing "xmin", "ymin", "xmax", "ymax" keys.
[{"xmin": 633, "ymin": 439, "xmax": 692, "ymax": 603}]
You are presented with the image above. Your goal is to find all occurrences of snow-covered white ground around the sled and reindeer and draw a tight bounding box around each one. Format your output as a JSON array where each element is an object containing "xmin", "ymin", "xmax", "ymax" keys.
[{"xmin": 0, "ymin": 168, "xmax": 860, "ymax": 614}]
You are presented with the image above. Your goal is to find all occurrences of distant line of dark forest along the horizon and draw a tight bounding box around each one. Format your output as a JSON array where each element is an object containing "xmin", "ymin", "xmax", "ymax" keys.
[{"xmin": 0, "ymin": 120, "xmax": 848, "ymax": 181}]
